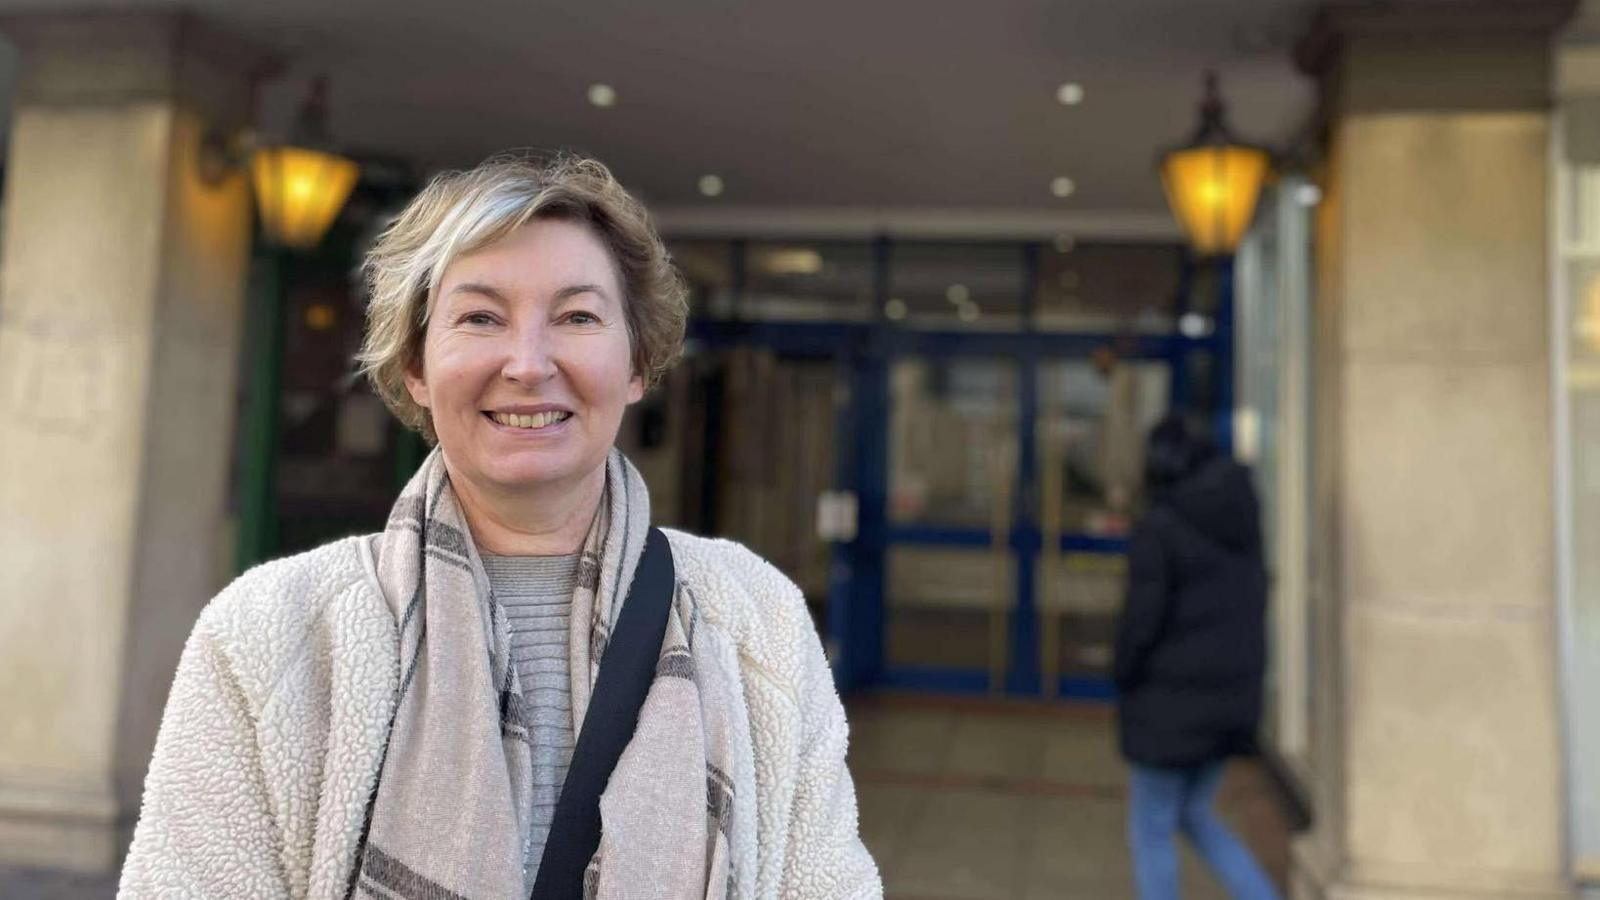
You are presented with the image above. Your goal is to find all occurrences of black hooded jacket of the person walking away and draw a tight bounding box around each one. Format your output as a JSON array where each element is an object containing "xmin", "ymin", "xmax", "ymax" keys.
[{"xmin": 1114, "ymin": 456, "xmax": 1267, "ymax": 767}]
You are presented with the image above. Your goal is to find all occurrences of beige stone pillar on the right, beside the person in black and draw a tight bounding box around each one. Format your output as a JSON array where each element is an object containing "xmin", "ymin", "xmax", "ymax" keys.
[{"xmin": 1291, "ymin": 0, "xmax": 1571, "ymax": 900}]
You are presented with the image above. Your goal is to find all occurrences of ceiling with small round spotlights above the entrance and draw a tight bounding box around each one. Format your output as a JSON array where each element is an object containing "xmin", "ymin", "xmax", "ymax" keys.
[{"xmin": 0, "ymin": 0, "xmax": 1312, "ymax": 235}]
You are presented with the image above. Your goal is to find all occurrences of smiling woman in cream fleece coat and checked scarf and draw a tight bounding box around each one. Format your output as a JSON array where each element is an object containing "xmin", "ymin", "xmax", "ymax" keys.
[{"xmin": 122, "ymin": 159, "xmax": 882, "ymax": 900}]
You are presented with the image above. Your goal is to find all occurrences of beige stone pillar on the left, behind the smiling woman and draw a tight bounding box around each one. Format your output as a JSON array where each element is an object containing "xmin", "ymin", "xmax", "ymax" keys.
[{"xmin": 0, "ymin": 14, "xmax": 272, "ymax": 871}]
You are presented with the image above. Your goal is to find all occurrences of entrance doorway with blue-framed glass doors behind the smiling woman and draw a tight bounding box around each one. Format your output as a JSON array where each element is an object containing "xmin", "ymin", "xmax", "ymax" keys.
[{"xmin": 662, "ymin": 240, "xmax": 1229, "ymax": 698}]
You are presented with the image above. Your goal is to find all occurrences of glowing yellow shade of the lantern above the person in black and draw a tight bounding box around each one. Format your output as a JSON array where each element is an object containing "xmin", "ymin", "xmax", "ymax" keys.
[{"xmin": 1162, "ymin": 144, "xmax": 1270, "ymax": 256}]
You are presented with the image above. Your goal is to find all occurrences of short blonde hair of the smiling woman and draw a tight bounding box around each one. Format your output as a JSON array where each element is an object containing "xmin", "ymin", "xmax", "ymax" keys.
[{"xmin": 357, "ymin": 155, "xmax": 688, "ymax": 442}]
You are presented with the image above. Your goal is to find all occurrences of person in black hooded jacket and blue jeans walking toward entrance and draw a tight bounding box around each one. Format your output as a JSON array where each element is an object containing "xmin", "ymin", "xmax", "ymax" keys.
[{"xmin": 1115, "ymin": 416, "xmax": 1277, "ymax": 900}]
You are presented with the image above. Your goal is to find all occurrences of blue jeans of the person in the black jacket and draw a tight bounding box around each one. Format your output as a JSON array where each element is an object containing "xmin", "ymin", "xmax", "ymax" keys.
[{"xmin": 1128, "ymin": 761, "xmax": 1278, "ymax": 900}]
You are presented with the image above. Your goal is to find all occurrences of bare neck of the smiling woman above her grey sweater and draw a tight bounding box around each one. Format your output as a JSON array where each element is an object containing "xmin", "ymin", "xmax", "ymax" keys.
[{"xmin": 450, "ymin": 466, "xmax": 605, "ymax": 556}]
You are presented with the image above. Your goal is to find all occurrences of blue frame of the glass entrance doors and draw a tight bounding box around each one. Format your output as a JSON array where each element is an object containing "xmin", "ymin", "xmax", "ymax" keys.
[{"xmin": 690, "ymin": 240, "xmax": 1232, "ymax": 700}]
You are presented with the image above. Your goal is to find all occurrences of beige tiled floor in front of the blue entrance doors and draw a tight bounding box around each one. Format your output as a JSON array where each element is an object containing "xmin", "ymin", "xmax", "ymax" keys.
[{"xmin": 850, "ymin": 695, "xmax": 1288, "ymax": 900}]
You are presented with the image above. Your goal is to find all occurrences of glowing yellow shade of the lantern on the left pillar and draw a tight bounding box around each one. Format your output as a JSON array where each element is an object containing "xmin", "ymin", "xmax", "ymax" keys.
[{"xmin": 251, "ymin": 147, "xmax": 362, "ymax": 250}]
